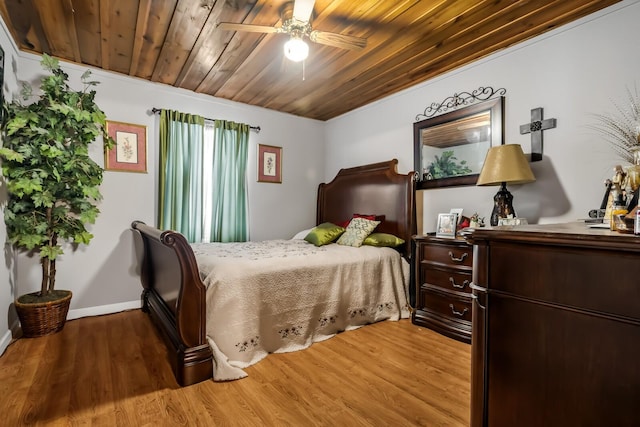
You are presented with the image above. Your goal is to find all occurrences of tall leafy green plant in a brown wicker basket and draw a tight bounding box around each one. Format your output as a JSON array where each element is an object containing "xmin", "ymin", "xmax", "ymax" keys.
[{"xmin": 0, "ymin": 54, "xmax": 113, "ymax": 337}]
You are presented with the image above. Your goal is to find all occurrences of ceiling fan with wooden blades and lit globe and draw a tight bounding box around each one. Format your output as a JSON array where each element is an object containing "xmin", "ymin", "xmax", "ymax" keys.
[{"xmin": 218, "ymin": 0, "xmax": 367, "ymax": 62}]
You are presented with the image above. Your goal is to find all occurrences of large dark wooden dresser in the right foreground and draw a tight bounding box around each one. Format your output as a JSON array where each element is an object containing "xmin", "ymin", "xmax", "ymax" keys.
[{"xmin": 466, "ymin": 223, "xmax": 640, "ymax": 427}]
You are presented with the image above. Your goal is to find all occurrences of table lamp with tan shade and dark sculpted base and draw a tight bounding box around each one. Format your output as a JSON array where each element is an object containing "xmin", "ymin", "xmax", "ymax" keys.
[{"xmin": 476, "ymin": 144, "xmax": 536, "ymax": 226}]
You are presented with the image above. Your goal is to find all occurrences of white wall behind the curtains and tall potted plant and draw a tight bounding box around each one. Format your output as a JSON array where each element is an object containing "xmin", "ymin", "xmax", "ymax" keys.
[{"xmin": 5, "ymin": 53, "xmax": 324, "ymax": 330}]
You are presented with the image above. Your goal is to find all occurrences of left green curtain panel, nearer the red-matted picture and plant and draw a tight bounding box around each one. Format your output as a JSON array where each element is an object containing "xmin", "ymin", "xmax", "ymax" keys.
[{"xmin": 158, "ymin": 110, "xmax": 204, "ymax": 242}]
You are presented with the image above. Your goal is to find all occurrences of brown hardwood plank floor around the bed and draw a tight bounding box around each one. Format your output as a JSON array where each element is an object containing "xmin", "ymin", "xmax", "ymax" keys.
[{"xmin": 0, "ymin": 310, "xmax": 471, "ymax": 426}]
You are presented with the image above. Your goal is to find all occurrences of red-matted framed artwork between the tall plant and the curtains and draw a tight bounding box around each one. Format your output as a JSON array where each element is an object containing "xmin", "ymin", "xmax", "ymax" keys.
[{"xmin": 104, "ymin": 120, "xmax": 147, "ymax": 173}]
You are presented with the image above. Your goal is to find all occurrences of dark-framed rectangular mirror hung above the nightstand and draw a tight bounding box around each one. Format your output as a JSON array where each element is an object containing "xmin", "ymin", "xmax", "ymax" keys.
[{"xmin": 413, "ymin": 96, "xmax": 504, "ymax": 190}]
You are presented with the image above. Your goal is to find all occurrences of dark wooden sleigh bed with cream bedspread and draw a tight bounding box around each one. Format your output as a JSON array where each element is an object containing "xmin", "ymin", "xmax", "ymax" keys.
[{"xmin": 132, "ymin": 159, "xmax": 415, "ymax": 386}]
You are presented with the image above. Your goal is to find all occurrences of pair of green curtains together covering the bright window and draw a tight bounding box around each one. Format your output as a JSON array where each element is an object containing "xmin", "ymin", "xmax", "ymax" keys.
[{"xmin": 158, "ymin": 110, "xmax": 250, "ymax": 242}]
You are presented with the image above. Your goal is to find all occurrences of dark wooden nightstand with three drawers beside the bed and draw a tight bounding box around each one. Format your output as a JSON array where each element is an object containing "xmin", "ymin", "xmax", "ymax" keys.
[{"xmin": 411, "ymin": 235, "xmax": 473, "ymax": 343}]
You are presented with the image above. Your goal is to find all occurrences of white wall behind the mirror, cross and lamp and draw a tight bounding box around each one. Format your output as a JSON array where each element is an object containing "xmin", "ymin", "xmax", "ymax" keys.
[{"xmin": 324, "ymin": 0, "xmax": 640, "ymax": 232}]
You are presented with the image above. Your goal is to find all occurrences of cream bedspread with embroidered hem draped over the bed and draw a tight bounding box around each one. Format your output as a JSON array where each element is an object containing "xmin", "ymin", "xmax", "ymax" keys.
[{"xmin": 191, "ymin": 239, "xmax": 409, "ymax": 381}]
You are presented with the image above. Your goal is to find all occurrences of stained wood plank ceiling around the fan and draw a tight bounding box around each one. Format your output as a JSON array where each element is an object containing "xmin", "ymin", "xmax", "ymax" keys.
[{"xmin": 0, "ymin": 0, "xmax": 619, "ymax": 120}]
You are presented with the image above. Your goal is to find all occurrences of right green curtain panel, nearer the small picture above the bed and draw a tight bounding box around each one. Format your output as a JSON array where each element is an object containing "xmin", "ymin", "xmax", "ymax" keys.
[{"xmin": 209, "ymin": 120, "xmax": 250, "ymax": 242}]
